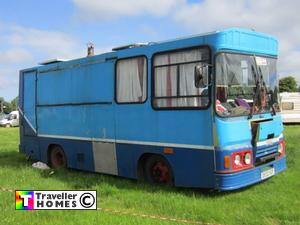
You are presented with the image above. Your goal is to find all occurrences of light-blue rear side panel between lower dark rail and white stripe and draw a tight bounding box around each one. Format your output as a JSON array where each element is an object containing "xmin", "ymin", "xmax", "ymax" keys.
[{"xmin": 37, "ymin": 105, "xmax": 115, "ymax": 139}]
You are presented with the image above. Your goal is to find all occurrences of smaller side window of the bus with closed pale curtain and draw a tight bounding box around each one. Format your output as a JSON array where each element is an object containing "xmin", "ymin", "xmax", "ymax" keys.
[{"xmin": 116, "ymin": 56, "xmax": 147, "ymax": 103}]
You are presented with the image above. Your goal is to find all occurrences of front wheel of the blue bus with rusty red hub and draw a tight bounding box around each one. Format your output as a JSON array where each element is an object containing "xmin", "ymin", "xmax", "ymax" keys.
[{"xmin": 144, "ymin": 155, "xmax": 174, "ymax": 186}]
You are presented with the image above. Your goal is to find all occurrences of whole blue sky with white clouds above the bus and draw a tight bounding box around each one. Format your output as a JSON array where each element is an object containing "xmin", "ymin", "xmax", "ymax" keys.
[{"xmin": 0, "ymin": 0, "xmax": 300, "ymax": 101}]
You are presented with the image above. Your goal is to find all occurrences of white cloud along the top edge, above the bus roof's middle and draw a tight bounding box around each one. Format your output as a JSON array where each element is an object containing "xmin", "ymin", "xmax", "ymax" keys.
[{"xmin": 73, "ymin": 0, "xmax": 185, "ymax": 20}]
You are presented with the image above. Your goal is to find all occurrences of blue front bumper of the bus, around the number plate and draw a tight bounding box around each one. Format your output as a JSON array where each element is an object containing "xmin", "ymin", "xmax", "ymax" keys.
[{"xmin": 215, "ymin": 156, "xmax": 286, "ymax": 191}]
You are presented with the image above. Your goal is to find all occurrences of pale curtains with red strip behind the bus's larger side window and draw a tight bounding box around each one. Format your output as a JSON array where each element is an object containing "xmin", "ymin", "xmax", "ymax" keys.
[{"xmin": 154, "ymin": 50, "xmax": 206, "ymax": 107}]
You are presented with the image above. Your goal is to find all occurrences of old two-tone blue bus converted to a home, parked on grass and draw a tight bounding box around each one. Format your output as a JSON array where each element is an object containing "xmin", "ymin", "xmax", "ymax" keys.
[{"xmin": 19, "ymin": 28, "xmax": 286, "ymax": 190}]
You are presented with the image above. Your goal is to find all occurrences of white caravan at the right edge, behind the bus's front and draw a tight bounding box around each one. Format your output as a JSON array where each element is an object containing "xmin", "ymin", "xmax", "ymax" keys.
[{"xmin": 280, "ymin": 92, "xmax": 300, "ymax": 123}]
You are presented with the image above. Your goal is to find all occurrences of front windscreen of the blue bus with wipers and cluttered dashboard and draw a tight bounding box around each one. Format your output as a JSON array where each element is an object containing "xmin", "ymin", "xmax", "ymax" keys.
[{"xmin": 216, "ymin": 53, "xmax": 279, "ymax": 116}]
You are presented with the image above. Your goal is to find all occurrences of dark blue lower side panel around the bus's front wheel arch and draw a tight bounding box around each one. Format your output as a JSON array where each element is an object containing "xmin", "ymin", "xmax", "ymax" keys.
[{"xmin": 117, "ymin": 144, "xmax": 215, "ymax": 188}]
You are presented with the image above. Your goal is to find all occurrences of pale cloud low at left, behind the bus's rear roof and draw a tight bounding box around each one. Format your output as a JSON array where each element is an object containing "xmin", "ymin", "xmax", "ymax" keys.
[{"xmin": 0, "ymin": 21, "xmax": 85, "ymax": 100}]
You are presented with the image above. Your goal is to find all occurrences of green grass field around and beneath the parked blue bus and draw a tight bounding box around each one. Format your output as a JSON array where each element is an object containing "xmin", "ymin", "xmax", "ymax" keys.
[{"xmin": 0, "ymin": 126, "xmax": 300, "ymax": 225}]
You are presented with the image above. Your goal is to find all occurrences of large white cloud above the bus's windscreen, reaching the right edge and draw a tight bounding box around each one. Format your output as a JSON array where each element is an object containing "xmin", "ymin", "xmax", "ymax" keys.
[{"xmin": 173, "ymin": 0, "xmax": 300, "ymax": 81}]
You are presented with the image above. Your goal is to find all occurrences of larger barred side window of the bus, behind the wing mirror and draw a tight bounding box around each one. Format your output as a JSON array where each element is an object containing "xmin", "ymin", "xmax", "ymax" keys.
[{"xmin": 153, "ymin": 48, "xmax": 209, "ymax": 108}]
